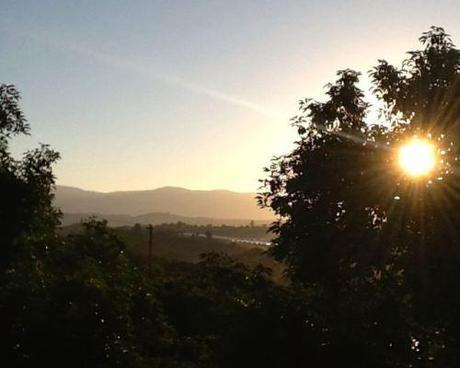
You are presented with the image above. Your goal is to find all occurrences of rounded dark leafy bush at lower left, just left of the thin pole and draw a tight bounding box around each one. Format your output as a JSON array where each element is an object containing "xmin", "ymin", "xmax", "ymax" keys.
[{"xmin": 35, "ymin": 220, "xmax": 175, "ymax": 367}]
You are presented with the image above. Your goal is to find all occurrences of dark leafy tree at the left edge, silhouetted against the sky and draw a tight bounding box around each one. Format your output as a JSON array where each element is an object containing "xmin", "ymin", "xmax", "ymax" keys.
[{"xmin": 0, "ymin": 84, "xmax": 59, "ymax": 267}]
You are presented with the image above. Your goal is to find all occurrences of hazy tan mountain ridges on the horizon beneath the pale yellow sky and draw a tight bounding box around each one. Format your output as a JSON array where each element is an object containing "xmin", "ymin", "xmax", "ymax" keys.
[{"xmin": 54, "ymin": 185, "xmax": 274, "ymax": 221}]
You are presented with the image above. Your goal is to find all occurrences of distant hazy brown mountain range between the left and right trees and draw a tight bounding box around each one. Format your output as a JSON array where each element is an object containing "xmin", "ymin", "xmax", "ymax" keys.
[{"xmin": 55, "ymin": 185, "xmax": 273, "ymax": 226}]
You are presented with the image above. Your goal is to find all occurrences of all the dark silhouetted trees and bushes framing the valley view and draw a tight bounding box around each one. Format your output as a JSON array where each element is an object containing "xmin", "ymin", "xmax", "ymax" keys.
[{"xmin": 0, "ymin": 28, "xmax": 460, "ymax": 368}]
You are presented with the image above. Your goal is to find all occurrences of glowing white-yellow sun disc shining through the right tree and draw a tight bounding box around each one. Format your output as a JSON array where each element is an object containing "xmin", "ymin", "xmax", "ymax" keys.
[{"xmin": 399, "ymin": 138, "xmax": 436, "ymax": 177}]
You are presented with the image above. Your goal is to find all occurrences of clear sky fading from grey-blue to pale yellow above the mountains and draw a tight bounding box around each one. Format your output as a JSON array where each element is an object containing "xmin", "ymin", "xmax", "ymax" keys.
[{"xmin": 0, "ymin": 0, "xmax": 460, "ymax": 191}]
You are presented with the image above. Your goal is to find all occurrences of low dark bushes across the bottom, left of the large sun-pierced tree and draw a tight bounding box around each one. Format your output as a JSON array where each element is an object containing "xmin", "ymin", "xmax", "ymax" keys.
[{"xmin": 0, "ymin": 218, "xmax": 312, "ymax": 367}]
